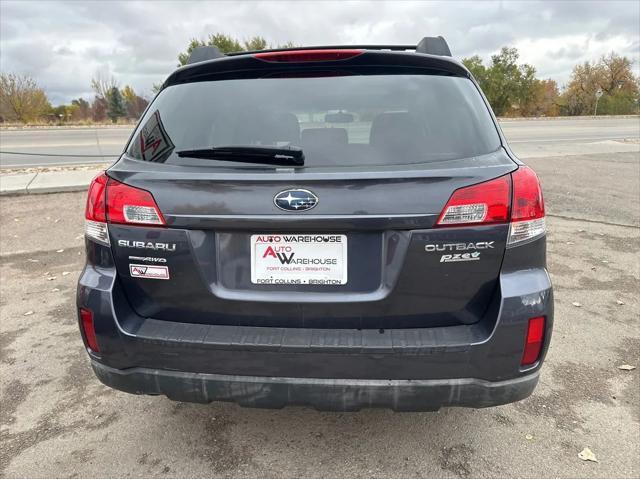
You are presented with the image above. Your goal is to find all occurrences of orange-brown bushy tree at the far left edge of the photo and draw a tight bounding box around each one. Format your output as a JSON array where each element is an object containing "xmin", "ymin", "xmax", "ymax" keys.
[{"xmin": 0, "ymin": 73, "xmax": 51, "ymax": 123}]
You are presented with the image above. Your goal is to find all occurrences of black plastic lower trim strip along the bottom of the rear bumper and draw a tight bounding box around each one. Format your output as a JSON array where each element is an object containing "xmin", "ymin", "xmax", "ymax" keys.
[{"xmin": 92, "ymin": 361, "xmax": 539, "ymax": 411}]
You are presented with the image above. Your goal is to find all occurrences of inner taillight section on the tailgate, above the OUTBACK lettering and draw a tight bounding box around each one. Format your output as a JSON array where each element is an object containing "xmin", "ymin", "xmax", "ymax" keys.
[{"xmin": 436, "ymin": 175, "xmax": 511, "ymax": 226}]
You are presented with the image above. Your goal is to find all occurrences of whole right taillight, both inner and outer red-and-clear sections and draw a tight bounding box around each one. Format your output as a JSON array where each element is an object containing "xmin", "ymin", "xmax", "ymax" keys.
[{"xmin": 436, "ymin": 166, "xmax": 546, "ymax": 247}]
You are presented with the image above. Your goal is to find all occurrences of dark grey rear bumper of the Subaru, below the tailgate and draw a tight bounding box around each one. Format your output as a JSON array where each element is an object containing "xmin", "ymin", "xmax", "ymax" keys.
[{"xmin": 77, "ymin": 237, "xmax": 553, "ymax": 411}]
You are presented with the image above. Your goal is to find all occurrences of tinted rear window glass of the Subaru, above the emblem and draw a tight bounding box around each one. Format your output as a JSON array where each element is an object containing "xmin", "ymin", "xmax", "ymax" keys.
[{"xmin": 127, "ymin": 74, "xmax": 500, "ymax": 168}]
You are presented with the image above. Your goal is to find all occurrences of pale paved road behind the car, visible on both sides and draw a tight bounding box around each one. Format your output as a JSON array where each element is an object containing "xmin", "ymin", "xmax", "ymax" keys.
[{"xmin": 0, "ymin": 117, "xmax": 640, "ymax": 168}]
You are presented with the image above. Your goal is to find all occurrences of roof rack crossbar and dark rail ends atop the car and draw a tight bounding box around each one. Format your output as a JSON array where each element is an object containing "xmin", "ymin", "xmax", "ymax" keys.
[{"xmin": 187, "ymin": 36, "xmax": 451, "ymax": 65}]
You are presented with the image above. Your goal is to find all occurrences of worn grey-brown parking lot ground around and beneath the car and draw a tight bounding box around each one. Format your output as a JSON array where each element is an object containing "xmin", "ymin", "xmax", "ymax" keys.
[{"xmin": 0, "ymin": 144, "xmax": 640, "ymax": 478}]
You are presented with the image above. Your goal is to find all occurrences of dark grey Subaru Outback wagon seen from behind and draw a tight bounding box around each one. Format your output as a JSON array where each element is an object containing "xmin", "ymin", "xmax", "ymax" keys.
[{"xmin": 77, "ymin": 37, "xmax": 553, "ymax": 411}]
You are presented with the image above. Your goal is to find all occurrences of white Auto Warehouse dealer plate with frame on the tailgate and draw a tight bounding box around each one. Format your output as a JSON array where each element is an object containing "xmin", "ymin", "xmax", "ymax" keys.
[{"xmin": 251, "ymin": 234, "xmax": 347, "ymax": 285}]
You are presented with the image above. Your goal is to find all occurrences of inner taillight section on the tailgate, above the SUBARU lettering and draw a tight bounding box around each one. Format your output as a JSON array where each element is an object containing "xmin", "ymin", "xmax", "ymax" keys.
[{"xmin": 107, "ymin": 179, "xmax": 166, "ymax": 226}]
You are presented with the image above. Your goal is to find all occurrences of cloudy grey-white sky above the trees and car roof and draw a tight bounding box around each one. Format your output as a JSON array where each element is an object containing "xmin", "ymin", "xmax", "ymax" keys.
[{"xmin": 0, "ymin": 0, "xmax": 640, "ymax": 105}]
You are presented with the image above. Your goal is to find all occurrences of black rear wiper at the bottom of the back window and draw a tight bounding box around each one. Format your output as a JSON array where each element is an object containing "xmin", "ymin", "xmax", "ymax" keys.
[{"xmin": 177, "ymin": 146, "xmax": 304, "ymax": 166}]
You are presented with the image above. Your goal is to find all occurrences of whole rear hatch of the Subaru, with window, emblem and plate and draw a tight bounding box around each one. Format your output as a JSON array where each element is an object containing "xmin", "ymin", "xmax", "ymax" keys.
[{"xmin": 108, "ymin": 52, "xmax": 516, "ymax": 329}]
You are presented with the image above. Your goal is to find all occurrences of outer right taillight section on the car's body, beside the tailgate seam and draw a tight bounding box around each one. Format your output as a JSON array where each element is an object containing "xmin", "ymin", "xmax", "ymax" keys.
[{"xmin": 507, "ymin": 166, "xmax": 547, "ymax": 246}]
